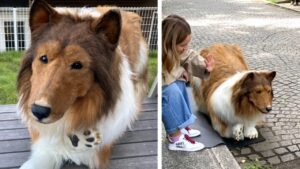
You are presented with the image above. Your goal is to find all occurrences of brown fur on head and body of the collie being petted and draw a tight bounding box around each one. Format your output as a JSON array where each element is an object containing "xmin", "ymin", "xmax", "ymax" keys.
[{"xmin": 192, "ymin": 44, "xmax": 276, "ymax": 136}]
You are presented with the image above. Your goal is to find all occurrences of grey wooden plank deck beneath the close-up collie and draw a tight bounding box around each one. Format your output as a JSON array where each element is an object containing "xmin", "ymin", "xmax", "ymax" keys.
[{"xmin": 0, "ymin": 98, "xmax": 157, "ymax": 169}]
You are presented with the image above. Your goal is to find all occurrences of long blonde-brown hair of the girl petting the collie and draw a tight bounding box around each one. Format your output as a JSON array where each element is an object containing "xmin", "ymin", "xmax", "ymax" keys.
[{"xmin": 162, "ymin": 15, "xmax": 191, "ymax": 72}]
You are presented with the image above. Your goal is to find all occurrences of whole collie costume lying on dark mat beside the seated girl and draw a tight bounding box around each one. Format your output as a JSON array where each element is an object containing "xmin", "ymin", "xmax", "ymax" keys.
[{"xmin": 192, "ymin": 44, "xmax": 276, "ymax": 141}]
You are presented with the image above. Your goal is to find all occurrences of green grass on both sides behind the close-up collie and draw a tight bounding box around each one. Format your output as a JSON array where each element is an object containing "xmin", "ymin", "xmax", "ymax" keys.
[{"xmin": 0, "ymin": 51, "xmax": 157, "ymax": 104}]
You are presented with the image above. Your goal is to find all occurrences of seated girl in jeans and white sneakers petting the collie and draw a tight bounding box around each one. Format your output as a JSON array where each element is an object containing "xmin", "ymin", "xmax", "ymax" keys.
[{"xmin": 162, "ymin": 15, "xmax": 214, "ymax": 151}]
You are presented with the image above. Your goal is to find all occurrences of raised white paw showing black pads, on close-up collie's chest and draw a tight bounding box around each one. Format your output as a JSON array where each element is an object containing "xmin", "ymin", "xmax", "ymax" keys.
[{"xmin": 69, "ymin": 129, "xmax": 101, "ymax": 150}]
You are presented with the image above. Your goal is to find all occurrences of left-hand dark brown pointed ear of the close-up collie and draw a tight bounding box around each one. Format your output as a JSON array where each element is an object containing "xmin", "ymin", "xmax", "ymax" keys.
[{"xmin": 29, "ymin": 0, "xmax": 57, "ymax": 31}]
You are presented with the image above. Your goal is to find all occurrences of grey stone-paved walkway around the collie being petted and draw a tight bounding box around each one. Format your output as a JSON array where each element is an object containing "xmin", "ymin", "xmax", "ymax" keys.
[{"xmin": 163, "ymin": 0, "xmax": 300, "ymax": 166}]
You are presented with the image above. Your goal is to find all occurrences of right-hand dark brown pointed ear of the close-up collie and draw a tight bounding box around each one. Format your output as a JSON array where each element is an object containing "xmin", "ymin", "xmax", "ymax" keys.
[{"xmin": 92, "ymin": 9, "xmax": 122, "ymax": 46}]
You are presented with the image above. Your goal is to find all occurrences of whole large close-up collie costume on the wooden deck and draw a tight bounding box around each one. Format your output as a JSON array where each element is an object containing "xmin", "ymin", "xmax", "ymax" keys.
[{"xmin": 18, "ymin": 0, "xmax": 148, "ymax": 169}]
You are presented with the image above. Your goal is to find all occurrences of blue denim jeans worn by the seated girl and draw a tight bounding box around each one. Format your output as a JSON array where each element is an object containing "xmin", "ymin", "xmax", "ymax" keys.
[{"xmin": 162, "ymin": 80, "xmax": 196, "ymax": 134}]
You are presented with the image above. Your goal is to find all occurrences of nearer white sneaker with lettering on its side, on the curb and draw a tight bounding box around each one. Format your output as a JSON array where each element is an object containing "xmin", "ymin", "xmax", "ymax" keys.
[{"xmin": 169, "ymin": 134, "xmax": 204, "ymax": 151}]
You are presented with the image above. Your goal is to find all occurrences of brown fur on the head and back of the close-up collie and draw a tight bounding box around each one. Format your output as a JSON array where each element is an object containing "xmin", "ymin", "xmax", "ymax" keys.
[{"xmin": 18, "ymin": 1, "xmax": 147, "ymax": 130}]
